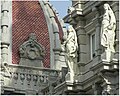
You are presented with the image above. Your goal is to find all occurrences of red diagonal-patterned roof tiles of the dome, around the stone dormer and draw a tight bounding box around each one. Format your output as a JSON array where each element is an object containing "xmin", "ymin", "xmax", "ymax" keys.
[{"xmin": 12, "ymin": 1, "xmax": 63, "ymax": 68}]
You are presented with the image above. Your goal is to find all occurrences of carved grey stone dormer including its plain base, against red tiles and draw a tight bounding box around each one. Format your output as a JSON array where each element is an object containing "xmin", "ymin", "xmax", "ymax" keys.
[{"xmin": 19, "ymin": 33, "xmax": 45, "ymax": 67}]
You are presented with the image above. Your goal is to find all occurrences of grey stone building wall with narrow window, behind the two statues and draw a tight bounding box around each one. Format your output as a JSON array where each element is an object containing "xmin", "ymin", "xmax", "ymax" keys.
[{"xmin": 64, "ymin": 0, "xmax": 119, "ymax": 95}]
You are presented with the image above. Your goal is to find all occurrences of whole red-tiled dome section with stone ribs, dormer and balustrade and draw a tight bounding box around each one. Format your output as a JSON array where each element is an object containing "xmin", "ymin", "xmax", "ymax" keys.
[{"xmin": 0, "ymin": 0, "xmax": 66, "ymax": 95}]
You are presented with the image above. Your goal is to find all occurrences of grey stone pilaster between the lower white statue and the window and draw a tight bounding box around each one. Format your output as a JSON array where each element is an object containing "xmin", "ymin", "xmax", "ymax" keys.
[{"xmin": 76, "ymin": 16, "xmax": 87, "ymax": 64}]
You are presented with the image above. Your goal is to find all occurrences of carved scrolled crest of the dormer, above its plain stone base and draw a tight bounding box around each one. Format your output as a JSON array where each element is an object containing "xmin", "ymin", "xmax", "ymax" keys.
[{"xmin": 19, "ymin": 33, "xmax": 45, "ymax": 60}]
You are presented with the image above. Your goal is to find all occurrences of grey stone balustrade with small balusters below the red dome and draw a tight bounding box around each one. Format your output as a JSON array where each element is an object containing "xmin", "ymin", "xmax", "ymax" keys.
[{"xmin": 2, "ymin": 64, "xmax": 60, "ymax": 94}]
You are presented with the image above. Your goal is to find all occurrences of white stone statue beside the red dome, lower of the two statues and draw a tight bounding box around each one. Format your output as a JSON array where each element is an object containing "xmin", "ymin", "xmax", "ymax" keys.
[{"xmin": 64, "ymin": 25, "xmax": 78, "ymax": 82}]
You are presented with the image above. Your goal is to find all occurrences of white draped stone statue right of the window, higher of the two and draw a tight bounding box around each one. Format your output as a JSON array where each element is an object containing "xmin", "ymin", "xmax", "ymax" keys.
[{"xmin": 101, "ymin": 3, "xmax": 116, "ymax": 61}]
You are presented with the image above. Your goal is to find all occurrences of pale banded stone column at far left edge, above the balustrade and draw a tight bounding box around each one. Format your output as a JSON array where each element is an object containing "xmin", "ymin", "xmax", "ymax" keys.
[{"xmin": 1, "ymin": 1, "xmax": 10, "ymax": 66}]
